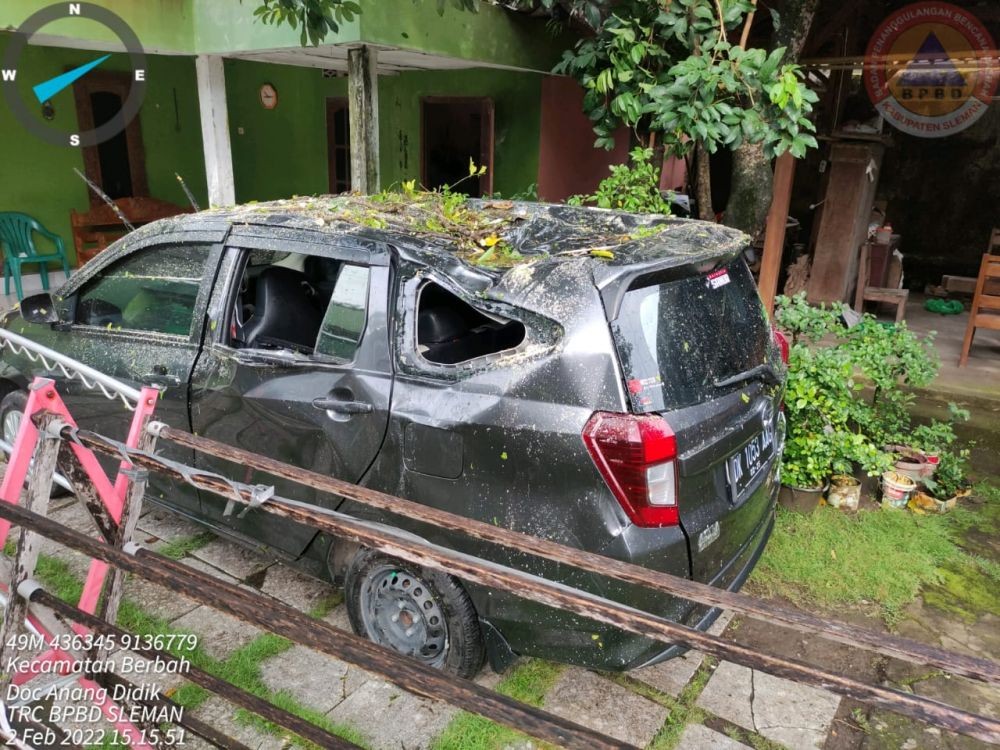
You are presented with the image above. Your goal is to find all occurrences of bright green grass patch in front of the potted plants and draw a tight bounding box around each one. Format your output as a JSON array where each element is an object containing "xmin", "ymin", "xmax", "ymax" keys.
[{"xmin": 750, "ymin": 486, "xmax": 1000, "ymax": 626}]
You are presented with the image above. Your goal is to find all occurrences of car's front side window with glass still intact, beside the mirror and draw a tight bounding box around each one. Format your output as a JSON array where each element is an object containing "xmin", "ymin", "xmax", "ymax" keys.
[{"xmin": 76, "ymin": 245, "xmax": 208, "ymax": 336}]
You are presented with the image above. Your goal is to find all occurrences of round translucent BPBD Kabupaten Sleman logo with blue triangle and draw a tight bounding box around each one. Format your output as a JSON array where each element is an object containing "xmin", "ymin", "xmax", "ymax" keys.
[{"xmin": 864, "ymin": 2, "xmax": 1000, "ymax": 138}]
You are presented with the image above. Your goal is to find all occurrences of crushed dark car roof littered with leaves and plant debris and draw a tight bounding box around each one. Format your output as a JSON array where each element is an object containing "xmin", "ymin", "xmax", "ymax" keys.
[{"xmin": 201, "ymin": 192, "xmax": 747, "ymax": 280}]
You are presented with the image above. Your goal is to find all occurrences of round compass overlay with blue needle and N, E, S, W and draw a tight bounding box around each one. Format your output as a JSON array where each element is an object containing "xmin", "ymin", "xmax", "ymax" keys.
[{"xmin": 0, "ymin": 2, "xmax": 146, "ymax": 147}]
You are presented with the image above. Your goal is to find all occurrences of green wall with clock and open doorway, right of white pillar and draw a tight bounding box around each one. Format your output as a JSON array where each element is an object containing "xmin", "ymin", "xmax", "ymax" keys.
[{"xmin": 226, "ymin": 60, "xmax": 542, "ymax": 202}]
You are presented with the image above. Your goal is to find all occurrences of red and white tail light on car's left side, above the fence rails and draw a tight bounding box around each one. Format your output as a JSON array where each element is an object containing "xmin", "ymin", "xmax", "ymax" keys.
[{"xmin": 583, "ymin": 411, "xmax": 680, "ymax": 527}]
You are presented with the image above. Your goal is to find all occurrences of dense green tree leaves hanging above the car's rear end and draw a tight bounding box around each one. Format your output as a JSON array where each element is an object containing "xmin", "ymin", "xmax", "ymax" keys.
[{"xmin": 546, "ymin": 0, "xmax": 817, "ymax": 156}]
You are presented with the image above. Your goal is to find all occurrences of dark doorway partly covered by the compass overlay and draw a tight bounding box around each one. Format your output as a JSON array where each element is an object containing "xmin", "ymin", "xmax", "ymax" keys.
[{"xmin": 73, "ymin": 73, "xmax": 149, "ymax": 206}]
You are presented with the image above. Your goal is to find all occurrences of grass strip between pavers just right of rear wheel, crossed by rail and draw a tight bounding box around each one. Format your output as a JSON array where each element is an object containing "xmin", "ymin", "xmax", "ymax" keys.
[{"xmin": 431, "ymin": 659, "xmax": 564, "ymax": 750}]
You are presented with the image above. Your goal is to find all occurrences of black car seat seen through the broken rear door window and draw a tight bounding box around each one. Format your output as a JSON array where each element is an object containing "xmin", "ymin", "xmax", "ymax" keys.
[{"xmin": 243, "ymin": 266, "xmax": 323, "ymax": 352}]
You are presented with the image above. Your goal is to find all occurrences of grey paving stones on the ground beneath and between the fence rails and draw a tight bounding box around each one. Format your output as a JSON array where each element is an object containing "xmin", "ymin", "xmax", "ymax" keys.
[{"xmin": 31, "ymin": 499, "xmax": 840, "ymax": 750}]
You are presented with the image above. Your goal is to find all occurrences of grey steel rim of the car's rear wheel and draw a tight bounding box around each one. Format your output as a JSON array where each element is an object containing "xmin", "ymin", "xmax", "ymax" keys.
[{"xmin": 361, "ymin": 565, "xmax": 448, "ymax": 667}]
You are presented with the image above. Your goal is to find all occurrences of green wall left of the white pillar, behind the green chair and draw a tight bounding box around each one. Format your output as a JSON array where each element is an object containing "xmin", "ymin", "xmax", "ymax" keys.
[{"xmin": 0, "ymin": 33, "xmax": 207, "ymax": 264}]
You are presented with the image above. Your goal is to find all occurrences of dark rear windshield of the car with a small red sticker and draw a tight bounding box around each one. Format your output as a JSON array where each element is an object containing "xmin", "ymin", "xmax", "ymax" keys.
[{"xmin": 612, "ymin": 258, "xmax": 771, "ymax": 412}]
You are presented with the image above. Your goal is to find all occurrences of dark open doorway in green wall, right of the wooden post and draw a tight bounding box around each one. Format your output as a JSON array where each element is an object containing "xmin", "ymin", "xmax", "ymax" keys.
[{"xmin": 420, "ymin": 96, "xmax": 493, "ymax": 198}]
